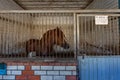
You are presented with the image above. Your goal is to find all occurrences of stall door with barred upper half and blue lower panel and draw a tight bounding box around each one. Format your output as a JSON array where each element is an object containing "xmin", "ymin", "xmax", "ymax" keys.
[{"xmin": 77, "ymin": 13, "xmax": 120, "ymax": 80}]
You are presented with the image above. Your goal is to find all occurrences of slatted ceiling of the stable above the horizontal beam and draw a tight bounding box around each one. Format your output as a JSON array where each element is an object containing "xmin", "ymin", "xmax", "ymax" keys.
[{"xmin": 13, "ymin": 0, "xmax": 93, "ymax": 10}]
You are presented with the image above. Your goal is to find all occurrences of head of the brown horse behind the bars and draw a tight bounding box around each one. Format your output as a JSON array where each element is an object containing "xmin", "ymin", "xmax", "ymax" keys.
[{"xmin": 54, "ymin": 27, "xmax": 69, "ymax": 49}]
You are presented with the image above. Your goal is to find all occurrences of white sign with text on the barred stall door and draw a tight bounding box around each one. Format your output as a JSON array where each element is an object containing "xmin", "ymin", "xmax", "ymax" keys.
[{"xmin": 95, "ymin": 15, "xmax": 108, "ymax": 25}]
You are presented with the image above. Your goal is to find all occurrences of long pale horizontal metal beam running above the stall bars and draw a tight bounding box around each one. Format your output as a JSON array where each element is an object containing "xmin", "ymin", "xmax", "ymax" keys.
[{"xmin": 0, "ymin": 9, "xmax": 120, "ymax": 14}]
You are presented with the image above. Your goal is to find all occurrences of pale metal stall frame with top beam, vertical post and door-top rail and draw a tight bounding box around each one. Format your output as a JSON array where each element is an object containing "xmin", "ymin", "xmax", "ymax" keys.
[{"xmin": 0, "ymin": 9, "xmax": 120, "ymax": 61}]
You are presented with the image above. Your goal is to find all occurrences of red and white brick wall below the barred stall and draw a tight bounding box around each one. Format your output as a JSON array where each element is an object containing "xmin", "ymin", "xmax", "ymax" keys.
[{"xmin": 0, "ymin": 62, "xmax": 77, "ymax": 80}]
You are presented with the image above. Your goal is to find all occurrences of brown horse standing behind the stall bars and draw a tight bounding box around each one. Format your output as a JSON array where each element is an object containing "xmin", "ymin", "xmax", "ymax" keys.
[{"xmin": 26, "ymin": 27, "xmax": 69, "ymax": 55}]
